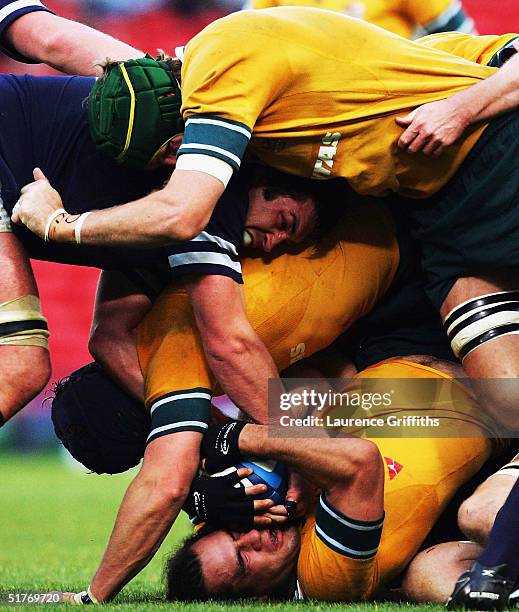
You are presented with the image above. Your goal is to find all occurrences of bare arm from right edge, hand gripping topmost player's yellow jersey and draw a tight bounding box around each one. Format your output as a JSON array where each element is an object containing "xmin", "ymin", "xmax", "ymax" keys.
[{"xmin": 396, "ymin": 40, "xmax": 519, "ymax": 157}]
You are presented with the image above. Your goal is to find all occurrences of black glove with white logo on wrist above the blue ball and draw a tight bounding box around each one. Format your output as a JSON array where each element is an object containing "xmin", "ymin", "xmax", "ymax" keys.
[{"xmin": 200, "ymin": 421, "xmax": 247, "ymax": 474}]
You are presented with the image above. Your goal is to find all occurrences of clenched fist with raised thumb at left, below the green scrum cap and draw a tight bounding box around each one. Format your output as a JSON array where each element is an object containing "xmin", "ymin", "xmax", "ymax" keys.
[{"xmin": 11, "ymin": 168, "xmax": 63, "ymax": 238}]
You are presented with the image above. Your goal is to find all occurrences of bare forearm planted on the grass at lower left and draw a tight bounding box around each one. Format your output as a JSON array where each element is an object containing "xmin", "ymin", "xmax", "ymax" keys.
[{"xmin": 90, "ymin": 431, "xmax": 202, "ymax": 601}]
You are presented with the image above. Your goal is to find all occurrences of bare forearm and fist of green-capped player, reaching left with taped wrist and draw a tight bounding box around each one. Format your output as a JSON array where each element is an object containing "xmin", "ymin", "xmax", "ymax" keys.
[{"xmin": 12, "ymin": 168, "xmax": 225, "ymax": 247}]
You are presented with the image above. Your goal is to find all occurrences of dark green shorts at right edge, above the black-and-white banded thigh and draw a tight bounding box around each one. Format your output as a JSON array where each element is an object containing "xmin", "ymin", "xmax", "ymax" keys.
[{"xmin": 400, "ymin": 111, "xmax": 519, "ymax": 309}]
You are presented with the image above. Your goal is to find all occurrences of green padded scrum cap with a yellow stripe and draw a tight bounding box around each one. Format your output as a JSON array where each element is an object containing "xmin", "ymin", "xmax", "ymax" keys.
[{"xmin": 88, "ymin": 55, "xmax": 184, "ymax": 168}]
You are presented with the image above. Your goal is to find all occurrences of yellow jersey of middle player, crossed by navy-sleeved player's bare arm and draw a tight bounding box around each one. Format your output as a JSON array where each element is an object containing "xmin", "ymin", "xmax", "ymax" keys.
[{"xmin": 137, "ymin": 203, "xmax": 399, "ymax": 420}]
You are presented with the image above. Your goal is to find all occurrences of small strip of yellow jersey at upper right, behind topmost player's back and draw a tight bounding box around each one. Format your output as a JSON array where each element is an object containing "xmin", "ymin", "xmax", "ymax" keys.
[{"xmin": 416, "ymin": 32, "xmax": 519, "ymax": 65}]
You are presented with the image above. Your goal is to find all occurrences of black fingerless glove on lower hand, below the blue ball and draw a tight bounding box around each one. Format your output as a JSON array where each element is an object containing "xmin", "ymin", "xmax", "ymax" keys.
[{"xmin": 184, "ymin": 472, "xmax": 254, "ymax": 531}]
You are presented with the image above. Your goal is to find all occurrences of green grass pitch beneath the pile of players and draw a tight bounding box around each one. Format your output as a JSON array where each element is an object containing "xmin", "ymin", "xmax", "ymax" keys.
[{"xmin": 0, "ymin": 453, "xmax": 442, "ymax": 612}]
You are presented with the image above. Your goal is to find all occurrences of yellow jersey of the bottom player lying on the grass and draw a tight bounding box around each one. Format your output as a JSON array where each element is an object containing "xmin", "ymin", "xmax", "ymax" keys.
[{"xmin": 298, "ymin": 359, "xmax": 492, "ymax": 601}]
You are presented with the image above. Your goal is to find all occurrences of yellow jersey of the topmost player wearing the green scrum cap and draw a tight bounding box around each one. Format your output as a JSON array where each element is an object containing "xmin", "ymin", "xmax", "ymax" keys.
[{"xmin": 179, "ymin": 7, "xmax": 494, "ymax": 198}]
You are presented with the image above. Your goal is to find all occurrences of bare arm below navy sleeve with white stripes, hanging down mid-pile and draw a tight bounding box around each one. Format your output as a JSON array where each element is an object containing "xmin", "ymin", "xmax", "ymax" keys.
[{"xmin": 187, "ymin": 275, "xmax": 279, "ymax": 423}]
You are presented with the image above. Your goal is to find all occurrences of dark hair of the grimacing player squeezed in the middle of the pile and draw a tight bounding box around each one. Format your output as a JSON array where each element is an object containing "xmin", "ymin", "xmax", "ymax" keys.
[{"xmin": 245, "ymin": 164, "xmax": 352, "ymax": 240}]
